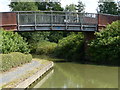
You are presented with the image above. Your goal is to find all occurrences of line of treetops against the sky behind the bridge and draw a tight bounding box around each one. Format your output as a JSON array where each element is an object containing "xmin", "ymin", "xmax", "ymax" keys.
[{"xmin": 9, "ymin": 0, "xmax": 120, "ymax": 15}]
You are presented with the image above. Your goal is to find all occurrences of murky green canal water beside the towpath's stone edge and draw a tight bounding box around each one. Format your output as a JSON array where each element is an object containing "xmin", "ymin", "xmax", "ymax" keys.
[{"xmin": 33, "ymin": 62, "xmax": 118, "ymax": 88}]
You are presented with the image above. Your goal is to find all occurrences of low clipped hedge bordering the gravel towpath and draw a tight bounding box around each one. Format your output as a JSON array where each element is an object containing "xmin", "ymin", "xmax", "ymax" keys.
[{"xmin": 0, "ymin": 52, "xmax": 32, "ymax": 71}]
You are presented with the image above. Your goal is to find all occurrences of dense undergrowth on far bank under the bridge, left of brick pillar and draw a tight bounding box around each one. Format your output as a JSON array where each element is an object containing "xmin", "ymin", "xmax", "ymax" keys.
[{"xmin": 30, "ymin": 33, "xmax": 84, "ymax": 61}]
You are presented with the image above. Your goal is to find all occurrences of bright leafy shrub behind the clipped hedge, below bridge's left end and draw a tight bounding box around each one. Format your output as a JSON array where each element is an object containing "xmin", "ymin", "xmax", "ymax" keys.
[{"xmin": 0, "ymin": 29, "xmax": 30, "ymax": 54}]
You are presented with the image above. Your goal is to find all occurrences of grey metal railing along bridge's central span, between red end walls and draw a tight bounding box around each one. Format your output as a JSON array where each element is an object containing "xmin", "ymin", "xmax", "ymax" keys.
[{"xmin": 17, "ymin": 11, "xmax": 98, "ymax": 30}]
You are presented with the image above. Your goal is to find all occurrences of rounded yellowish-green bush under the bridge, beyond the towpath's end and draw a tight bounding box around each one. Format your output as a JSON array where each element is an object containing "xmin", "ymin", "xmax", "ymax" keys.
[{"xmin": 32, "ymin": 41, "xmax": 57, "ymax": 55}]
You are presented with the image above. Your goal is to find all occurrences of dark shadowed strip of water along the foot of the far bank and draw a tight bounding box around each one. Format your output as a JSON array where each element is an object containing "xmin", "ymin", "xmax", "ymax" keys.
[{"xmin": 32, "ymin": 54, "xmax": 120, "ymax": 67}]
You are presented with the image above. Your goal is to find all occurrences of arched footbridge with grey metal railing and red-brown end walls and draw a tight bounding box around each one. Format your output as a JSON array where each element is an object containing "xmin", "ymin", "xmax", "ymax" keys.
[{"xmin": 0, "ymin": 11, "xmax": 120, "ymax": 32}]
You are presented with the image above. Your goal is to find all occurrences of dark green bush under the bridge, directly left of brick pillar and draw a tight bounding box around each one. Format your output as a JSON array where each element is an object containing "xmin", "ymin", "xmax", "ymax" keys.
[{"xmin": 55, "ymin": 33, "xmax": 84, "ymax": 60}]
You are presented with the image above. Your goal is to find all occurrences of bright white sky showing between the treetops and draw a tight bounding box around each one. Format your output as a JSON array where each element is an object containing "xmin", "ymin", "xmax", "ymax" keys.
[{"xmin": 0, "ymin": 0, "xmax": 118, "ymax": 13}]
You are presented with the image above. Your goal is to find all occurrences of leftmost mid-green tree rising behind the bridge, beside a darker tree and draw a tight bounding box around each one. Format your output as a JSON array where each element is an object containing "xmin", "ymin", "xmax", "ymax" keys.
[{"xmin": 9, "ymin": 2, "xmax": 38, "ymax": 11}]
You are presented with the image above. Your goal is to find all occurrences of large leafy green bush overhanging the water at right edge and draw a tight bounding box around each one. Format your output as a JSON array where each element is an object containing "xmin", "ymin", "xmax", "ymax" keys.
[{"xmin": 88, "ymin": 21, "xmax": 120, "ymax": 64}]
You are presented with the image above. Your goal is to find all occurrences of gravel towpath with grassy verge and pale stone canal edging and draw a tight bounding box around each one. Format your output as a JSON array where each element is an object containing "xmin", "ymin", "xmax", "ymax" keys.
[{"xmin": 0, "ymin": 59, "xmax": 54, "ymax": 88}]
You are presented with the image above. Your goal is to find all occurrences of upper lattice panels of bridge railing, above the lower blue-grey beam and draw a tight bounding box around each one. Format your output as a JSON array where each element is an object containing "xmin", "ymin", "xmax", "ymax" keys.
[{"xmin": 18, "ymin": 11, "xmax": 97, "ymax": 25}]
